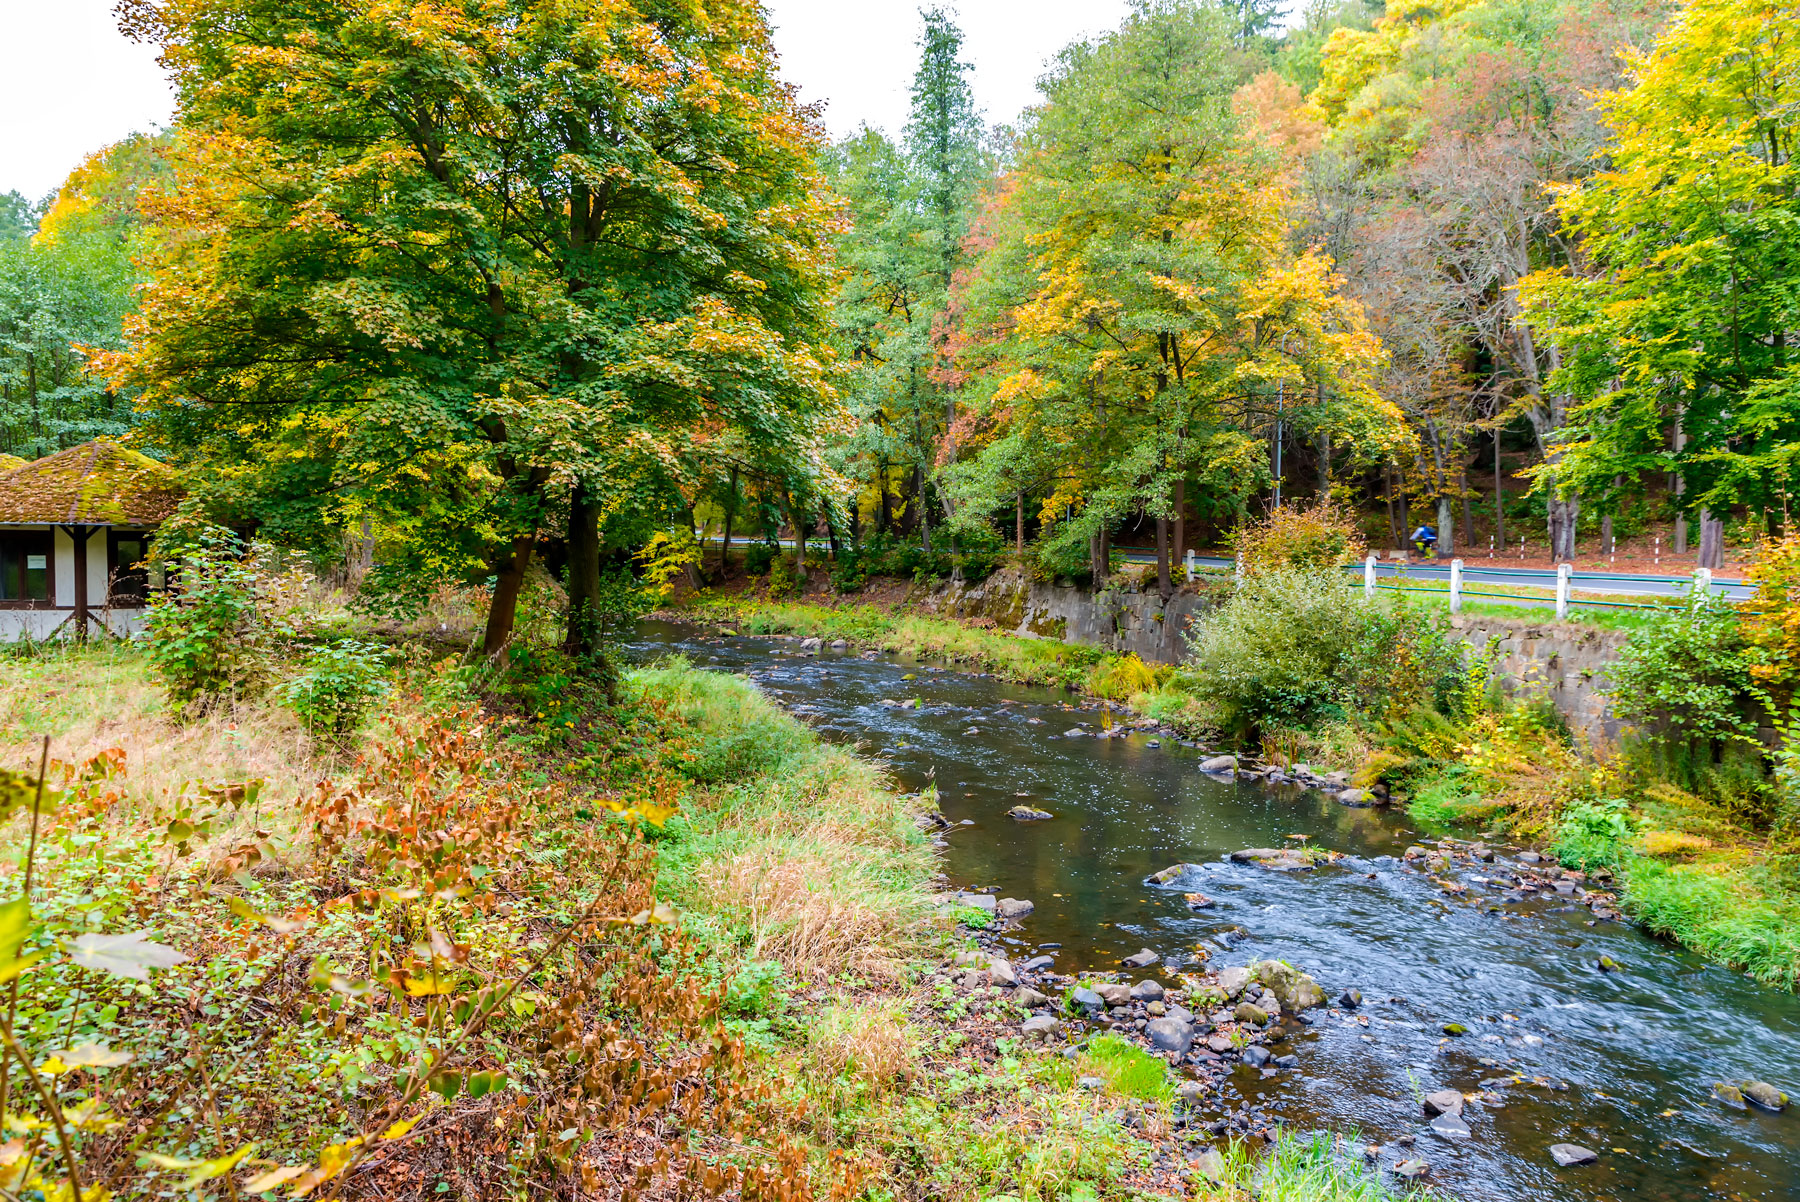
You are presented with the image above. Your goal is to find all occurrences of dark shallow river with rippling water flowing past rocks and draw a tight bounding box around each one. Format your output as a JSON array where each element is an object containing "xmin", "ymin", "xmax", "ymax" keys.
[{"xmin": 632, "ymin": 623, "xmax": 1800, "ymax": 1202}]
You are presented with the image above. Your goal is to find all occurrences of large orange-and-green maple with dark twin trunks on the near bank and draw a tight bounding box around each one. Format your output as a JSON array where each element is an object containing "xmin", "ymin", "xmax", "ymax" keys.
[{"xmin": 103, "ymin": 0, "xmax": 837, "ymax": 653}]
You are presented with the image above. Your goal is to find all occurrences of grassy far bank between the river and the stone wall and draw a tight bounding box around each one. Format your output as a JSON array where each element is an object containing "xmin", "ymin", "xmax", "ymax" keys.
[{"xmin": 682, "ymin": 594, "xmax": 1800, "ymax": 990}]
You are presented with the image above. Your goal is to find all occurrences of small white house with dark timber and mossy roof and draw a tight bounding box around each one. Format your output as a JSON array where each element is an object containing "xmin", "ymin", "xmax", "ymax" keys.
[{"xmin": 0, "ymin": 439, "xmax": 182, "ymax": 641}]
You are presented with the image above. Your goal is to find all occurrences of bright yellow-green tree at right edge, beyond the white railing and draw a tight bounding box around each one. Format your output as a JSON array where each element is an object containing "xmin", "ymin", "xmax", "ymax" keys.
[{"xmin": 1523, "ymin": 0, "xmax": 1800, "ymax": 567}]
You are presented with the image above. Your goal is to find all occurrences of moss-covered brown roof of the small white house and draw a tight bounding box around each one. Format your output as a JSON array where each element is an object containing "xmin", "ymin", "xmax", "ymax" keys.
[{"xmin": 0, "ymin": 439, "xmax": 184, "ymax": 525}]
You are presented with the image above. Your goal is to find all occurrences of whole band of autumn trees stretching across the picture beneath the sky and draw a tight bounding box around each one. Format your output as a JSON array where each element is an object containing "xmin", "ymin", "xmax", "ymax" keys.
[{"xmin": 0, "ymin": 0, "xmax": 1800, "ymax": 665}]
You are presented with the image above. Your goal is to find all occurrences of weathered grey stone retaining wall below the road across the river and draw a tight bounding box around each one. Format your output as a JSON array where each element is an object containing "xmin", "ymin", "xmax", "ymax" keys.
[{"xmin": 918, "ymin": 569, "xmax": 1625, "ymax": 741}]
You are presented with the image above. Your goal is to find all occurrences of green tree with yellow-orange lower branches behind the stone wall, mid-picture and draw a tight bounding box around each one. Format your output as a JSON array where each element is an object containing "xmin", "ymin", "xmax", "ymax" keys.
[{"xmin": 936, "ymin": 0, "xmax": 1397, "ymax": 594}]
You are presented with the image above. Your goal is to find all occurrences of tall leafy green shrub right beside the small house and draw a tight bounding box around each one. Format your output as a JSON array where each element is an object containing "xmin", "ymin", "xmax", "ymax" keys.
[{"xmin": 146, "ymin": 513, "xmax": 268, "ymax": 713}]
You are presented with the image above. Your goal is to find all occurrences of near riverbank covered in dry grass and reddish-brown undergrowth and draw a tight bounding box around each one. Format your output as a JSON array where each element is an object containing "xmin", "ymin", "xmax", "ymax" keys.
[{"xmin": 0, "ymin": 644, "xmax": 1432, "ymax": 1202}]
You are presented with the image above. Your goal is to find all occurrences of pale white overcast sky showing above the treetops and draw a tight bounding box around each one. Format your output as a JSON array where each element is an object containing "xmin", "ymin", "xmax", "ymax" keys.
[{"xmin": 0, "ymin": 0, "xmax": 1129, "ymax": 200}]
